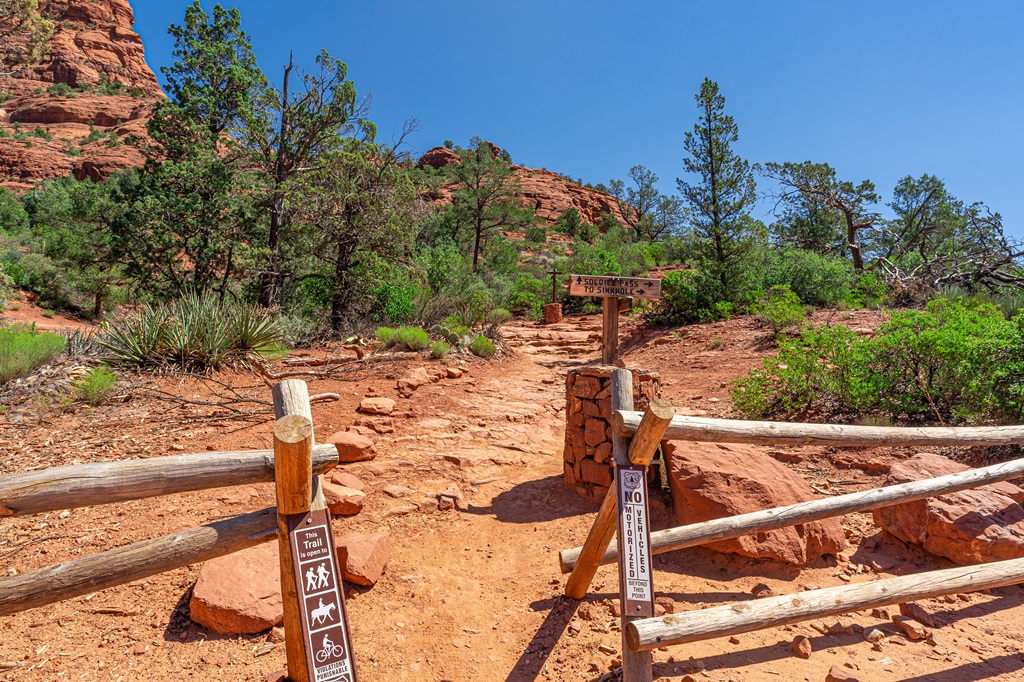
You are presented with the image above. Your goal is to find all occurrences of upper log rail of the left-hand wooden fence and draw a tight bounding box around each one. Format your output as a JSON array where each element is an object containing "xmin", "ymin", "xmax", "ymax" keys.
[{"xmin": 0, "ymin": 445, "xmax": 338, "ymax": 516}]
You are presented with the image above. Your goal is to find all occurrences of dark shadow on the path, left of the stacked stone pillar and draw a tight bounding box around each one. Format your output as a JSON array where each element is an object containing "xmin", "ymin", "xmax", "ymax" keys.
[{"xmin": 466, "ymin": 476, "xmax": 598, "ymax": 523}]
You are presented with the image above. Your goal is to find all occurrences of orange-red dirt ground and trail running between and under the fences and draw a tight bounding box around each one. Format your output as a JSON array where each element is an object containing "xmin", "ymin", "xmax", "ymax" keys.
[{"xmin": 0, "ymin": 317, "xmax": 1024, "ymax": 682}]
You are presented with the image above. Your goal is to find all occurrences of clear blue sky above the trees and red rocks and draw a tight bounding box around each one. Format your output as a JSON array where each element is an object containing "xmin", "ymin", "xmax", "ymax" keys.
[{"xmin": 133, "ymin": 0, "xmax": 1024, "ymax": 233}]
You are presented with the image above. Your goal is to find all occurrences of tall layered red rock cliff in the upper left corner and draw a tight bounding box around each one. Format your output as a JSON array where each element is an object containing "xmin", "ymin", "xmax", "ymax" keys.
[{"xmin": 0, "ymin": 0, "xmax": 164, "ymax": 189}]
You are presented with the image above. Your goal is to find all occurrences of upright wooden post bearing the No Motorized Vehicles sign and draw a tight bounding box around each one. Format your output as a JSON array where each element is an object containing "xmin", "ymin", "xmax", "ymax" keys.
[{"xmin": 605, "ymin": 368, "xmax": 654, "ymax": 682}]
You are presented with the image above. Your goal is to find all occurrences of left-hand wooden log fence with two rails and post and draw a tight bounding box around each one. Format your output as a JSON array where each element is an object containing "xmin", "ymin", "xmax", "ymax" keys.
[{"xmin": 0, "ymin": 380, "xmax": 355, "ymax": 682}]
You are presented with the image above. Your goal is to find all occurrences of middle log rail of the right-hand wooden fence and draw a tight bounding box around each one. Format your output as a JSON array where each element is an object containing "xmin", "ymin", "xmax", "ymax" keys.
[{"xmin": 559, "ymin": 459, "xmax": 1024, "ymax": 573}]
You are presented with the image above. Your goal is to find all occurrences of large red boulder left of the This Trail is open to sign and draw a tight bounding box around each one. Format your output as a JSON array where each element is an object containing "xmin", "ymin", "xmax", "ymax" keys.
[{"xmin": 188, "ymin": 542, "xmax": 285, "ymax": 635}]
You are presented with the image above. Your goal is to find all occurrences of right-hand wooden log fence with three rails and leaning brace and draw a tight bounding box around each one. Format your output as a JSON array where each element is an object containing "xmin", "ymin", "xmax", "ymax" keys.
[{"xmin": 558, "ymin": 370, "xmax": 1024, "ymax": 682}]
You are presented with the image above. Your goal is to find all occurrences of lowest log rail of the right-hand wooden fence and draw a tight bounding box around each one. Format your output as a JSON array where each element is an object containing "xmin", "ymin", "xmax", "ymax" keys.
[{"xmin": 625, "ymin": 559, "xmax": 1024, "ymax": 651}]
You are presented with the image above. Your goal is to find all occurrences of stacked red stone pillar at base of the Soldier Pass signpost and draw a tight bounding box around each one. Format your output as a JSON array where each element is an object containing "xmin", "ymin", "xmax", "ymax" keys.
[{"xmin": 562, "ymin": 365, "xmax": 662, "ymax": 502}]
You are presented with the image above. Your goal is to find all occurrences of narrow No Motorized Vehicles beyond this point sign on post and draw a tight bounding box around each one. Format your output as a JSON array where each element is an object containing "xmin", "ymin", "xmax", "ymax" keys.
[{"xmin": 615, "ymin": 465, "xmax": 654, "ymax": 617}]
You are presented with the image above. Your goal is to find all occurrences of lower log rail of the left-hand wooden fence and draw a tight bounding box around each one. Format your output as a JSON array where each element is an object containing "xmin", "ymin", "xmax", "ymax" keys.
[{"xmin": 0, "ymin": 507, "xmax": 278, "ymax": 615}]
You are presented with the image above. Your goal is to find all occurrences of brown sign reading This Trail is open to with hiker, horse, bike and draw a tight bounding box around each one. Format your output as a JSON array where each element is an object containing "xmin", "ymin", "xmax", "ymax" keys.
[{"xmin": 287, "ymin": 509, "xmax": 356, "ymax": 682}]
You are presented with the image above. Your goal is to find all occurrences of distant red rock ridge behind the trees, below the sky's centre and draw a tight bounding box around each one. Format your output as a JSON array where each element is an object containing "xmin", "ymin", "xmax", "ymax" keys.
[{"xmin": 419, "ymin": 145, "xmax": 626, "ymax": 224}]
